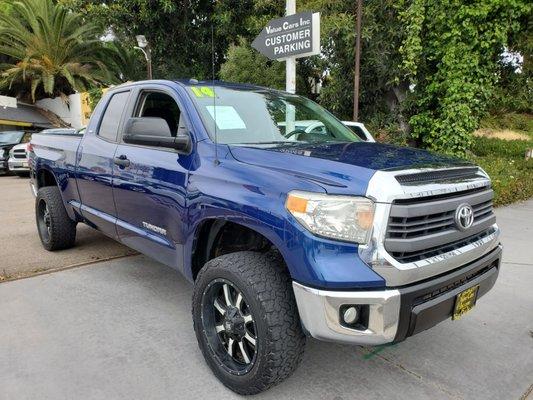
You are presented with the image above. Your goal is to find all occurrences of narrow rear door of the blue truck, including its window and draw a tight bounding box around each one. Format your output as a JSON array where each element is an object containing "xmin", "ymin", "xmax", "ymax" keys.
[{"xmin": 76, "ymin": 90, "xmax": 130, "ymax": 238}]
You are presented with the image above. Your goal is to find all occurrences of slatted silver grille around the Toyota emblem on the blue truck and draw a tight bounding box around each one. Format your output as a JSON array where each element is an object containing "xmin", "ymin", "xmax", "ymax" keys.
[{"xmin": 384, "ymin": 187, "xmax": 496, "ymax": 262}]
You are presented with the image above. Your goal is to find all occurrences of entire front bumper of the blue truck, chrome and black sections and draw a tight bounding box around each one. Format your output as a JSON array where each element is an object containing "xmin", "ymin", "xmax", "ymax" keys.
[{"xmin": 293, "ymin": 246, "xmax": 502, "ymax": 345}]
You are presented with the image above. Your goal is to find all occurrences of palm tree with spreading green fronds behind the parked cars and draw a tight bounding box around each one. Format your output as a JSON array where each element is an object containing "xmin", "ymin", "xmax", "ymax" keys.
[{"xmin": 0, "ymin": 0, "xmax": 114, "ymax": 101}]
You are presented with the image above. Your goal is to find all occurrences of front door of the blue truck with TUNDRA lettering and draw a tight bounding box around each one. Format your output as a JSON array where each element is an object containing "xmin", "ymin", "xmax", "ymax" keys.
[{"xmin": 113, "ymin": 85, "xmax": 192, "ymax": 269}]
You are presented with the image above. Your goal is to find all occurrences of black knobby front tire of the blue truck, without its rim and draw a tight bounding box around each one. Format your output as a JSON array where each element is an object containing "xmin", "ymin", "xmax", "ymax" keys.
[{"xmin": 192, "ymin": 251, "xmax": 305, "ymax": 395}]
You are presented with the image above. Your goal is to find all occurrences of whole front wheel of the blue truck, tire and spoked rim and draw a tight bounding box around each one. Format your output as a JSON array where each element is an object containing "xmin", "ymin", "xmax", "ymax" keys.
[{"xmin": 192, "ymin": 251, "xmax": 305, "ymax": 394}]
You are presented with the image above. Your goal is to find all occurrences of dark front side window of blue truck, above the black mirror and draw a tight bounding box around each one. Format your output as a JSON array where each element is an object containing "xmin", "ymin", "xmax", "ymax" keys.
[{"xmin": 134, "ymin": 92, "xmax": 184, "ymax": 137}]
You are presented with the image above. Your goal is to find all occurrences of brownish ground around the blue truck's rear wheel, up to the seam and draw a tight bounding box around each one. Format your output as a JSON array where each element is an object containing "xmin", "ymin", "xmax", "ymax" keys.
[{"xmin": 0, "ymin": 176, "xmax": 136, "ymax": 281}]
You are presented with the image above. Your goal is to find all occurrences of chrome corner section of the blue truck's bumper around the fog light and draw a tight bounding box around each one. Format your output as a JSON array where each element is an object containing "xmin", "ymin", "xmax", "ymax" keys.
[{"xmin": 292, "ymin": 282, "xmax": 400, "ymax": 345}]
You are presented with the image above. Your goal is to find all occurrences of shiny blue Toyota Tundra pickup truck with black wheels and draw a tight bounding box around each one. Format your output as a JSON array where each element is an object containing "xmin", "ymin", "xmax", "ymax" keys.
[{"xmin": 30, "ymin": 80, "xmax": 501, "ymax": 394}]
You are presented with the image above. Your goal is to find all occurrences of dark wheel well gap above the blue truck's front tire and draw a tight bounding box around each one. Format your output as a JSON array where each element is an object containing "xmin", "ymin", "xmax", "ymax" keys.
[{"xmin": 191, "ymin": 220, "xmax": 278, "ymax": 280}]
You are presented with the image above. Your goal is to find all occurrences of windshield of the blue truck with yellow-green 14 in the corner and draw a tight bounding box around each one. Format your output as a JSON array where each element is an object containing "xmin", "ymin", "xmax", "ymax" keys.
[{"xmin": 188, "ymin": 86, "xmax": 360, "ymax": 146}]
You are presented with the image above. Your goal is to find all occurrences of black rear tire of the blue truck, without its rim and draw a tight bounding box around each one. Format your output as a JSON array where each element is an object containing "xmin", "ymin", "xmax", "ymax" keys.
[{"xmin": 35, "ymin": 186, "xmax": 76, "ymax": 251}]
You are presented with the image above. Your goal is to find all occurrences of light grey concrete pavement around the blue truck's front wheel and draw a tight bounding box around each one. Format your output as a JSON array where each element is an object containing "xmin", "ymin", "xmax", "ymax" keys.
[{"xmin": 0, "ymin": 200, "xmax": 533, "ymax": 400}]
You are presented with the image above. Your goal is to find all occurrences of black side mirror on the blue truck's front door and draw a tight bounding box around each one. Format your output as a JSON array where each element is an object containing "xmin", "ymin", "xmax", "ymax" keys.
[{"xmin": 122, "ymin": 117, "xmax": 191, "ymax": 152}]
